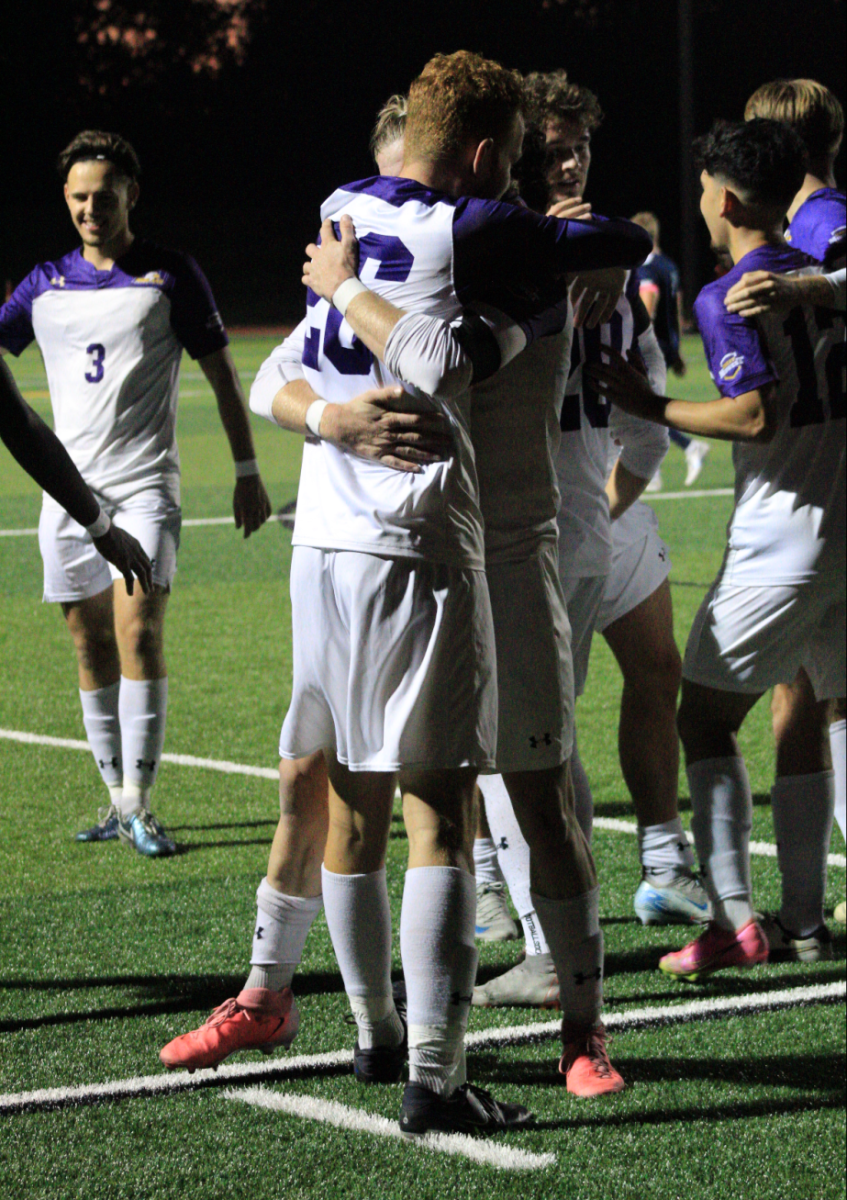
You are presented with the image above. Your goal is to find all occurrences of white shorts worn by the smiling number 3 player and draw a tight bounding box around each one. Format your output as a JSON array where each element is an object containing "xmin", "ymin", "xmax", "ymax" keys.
[{"xmin": 38, "ymin": 488, "xmax": 182, "ymax": 604}]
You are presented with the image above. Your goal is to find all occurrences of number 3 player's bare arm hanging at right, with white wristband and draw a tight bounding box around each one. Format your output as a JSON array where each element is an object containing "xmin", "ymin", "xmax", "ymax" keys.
[{"xmin": 197, "ymin": 346, "xmax": 271, "ymax": 538}]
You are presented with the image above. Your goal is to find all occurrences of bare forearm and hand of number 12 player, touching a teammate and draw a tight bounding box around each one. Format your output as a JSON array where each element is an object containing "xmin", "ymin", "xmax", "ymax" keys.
[{"xmin": 583, "ymin": 346, "xmax": 776, "ymax": 442}]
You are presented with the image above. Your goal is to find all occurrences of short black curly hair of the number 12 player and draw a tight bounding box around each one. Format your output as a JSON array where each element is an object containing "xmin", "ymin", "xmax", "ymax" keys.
[{"xmin": 695, "ymin": 116, "xmax": 809, "ymax": 211}]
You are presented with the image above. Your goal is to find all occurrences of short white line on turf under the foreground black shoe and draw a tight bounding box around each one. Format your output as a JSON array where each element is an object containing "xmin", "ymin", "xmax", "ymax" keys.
[{"xmin": 223, "ymin": 1087, "xmax": 555, "ymax": 1171}]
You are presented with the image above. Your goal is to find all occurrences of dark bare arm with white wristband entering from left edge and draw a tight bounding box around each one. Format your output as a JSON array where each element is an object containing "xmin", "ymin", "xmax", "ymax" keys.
[{"xmin": 0, "ymin": 360, "xmax": 152, "ymax": 595}]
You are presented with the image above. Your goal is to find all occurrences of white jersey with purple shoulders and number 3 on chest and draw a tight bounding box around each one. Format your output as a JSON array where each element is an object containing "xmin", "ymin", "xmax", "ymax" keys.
[{"xmin": 0, "ymin": 239, "xmax": 228, "ymax": 508}]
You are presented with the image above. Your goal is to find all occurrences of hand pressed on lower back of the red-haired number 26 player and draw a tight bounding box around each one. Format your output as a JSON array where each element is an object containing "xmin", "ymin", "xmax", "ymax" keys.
[{"xmin": 320, "ymin": 384, "xmax": 456, "ymax": 474}]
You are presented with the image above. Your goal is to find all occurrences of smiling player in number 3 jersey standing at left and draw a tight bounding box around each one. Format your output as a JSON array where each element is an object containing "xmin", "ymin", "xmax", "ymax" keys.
[{"xmin": 0, "ymin": 131, "xmax": 270, "ymax": 857}]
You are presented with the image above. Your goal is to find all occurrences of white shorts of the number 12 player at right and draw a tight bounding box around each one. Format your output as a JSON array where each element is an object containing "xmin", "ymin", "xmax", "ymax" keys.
[{"xmin": 683, "ymin": 575, "xmax": 847, "ymax": 700}]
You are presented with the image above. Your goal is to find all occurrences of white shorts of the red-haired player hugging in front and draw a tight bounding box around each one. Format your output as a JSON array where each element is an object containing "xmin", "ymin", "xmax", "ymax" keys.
[{"xmin": 280, "ymin": 546, "xmax": 497, "ymax": 772}]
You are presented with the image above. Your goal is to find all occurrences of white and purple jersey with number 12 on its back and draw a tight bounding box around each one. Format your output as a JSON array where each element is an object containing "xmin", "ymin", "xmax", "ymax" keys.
[{"xmin": 695, "ymin": 246, "xmax": 847, "ymax": 587}]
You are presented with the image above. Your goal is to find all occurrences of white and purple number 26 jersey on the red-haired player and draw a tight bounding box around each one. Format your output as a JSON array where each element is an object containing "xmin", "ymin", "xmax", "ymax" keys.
[{"xmin": 273, "ymin": 176, "xmax": 645, "ymax": 568}]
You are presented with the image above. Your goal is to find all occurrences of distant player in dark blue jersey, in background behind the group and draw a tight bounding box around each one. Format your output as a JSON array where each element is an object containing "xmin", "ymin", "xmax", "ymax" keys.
[{"xmin": 632, "ymin": 212, "xmax": 710, "ymax": 492}]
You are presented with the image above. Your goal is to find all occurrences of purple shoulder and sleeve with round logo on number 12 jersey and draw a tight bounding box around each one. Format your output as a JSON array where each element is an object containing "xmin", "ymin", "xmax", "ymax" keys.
[{"xmin": 693, "ymin": 246, "xmax": 811, "ymax": 396}]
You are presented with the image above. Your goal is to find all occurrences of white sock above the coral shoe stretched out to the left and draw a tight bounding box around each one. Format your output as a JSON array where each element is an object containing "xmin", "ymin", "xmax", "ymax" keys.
[{"xmin": 245, "ymin": 878, "xmax": 324, "ymax": 991}]
